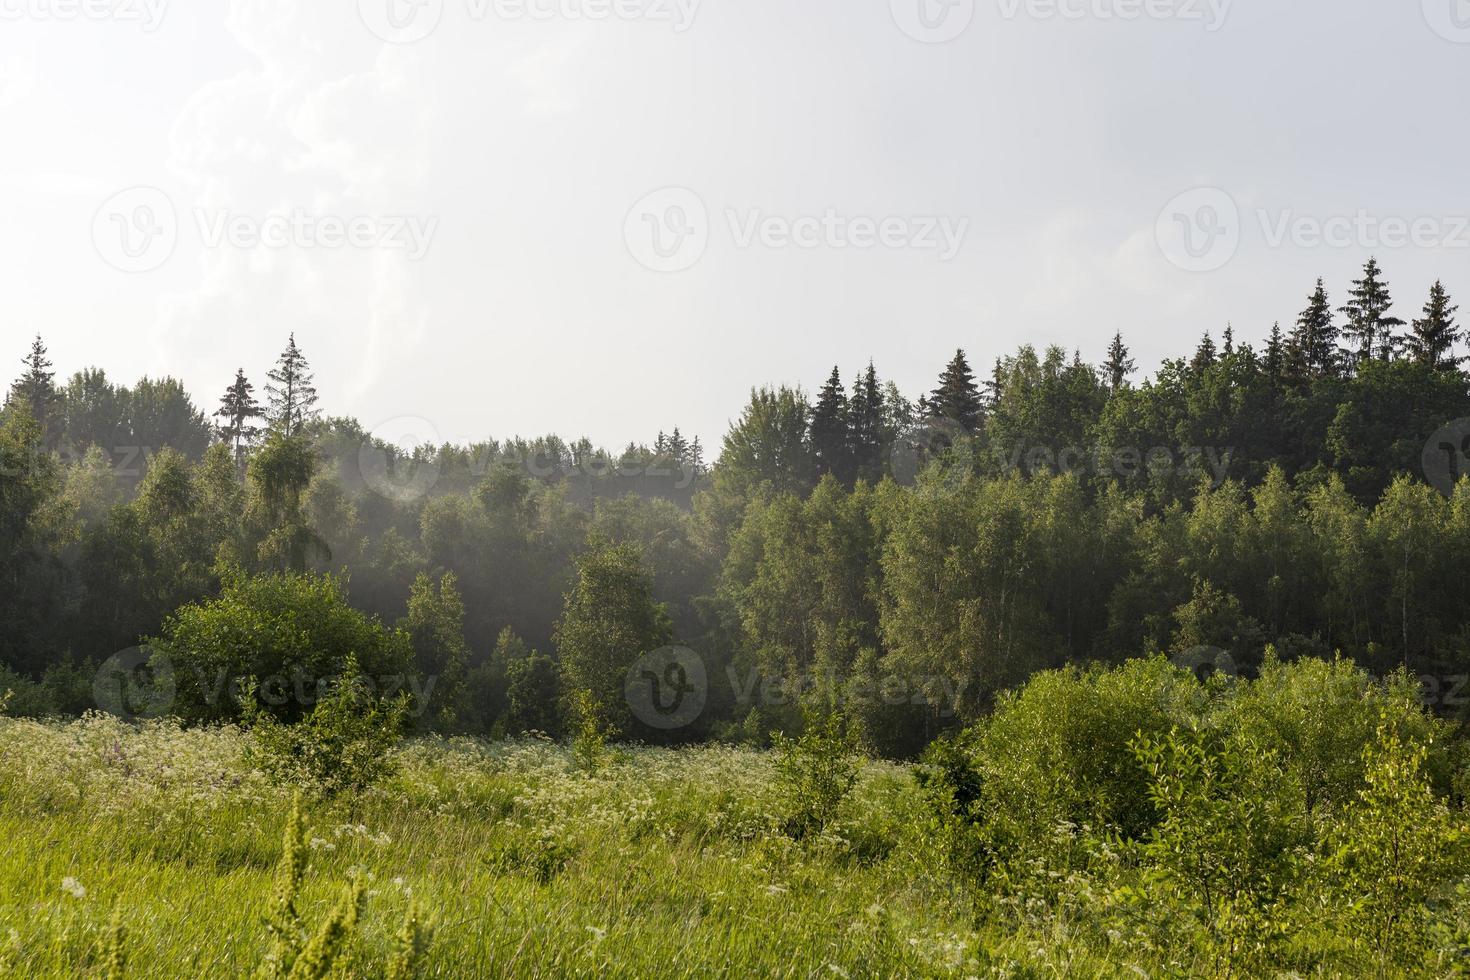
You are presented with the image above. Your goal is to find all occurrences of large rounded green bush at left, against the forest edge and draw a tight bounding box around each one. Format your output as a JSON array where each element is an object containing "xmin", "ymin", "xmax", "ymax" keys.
[{"xmin": 148, "ymin": 573, "xmax": 413, "ymax": 723}]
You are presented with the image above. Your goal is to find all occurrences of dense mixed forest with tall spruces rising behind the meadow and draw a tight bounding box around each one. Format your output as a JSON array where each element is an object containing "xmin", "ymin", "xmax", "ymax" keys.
[{"xmin": 0, "ymin": 260, "xmax": 1470, "ymax": 754}]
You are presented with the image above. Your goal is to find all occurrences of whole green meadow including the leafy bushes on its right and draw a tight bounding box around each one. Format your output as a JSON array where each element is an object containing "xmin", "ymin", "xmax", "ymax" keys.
[{"xmin": 0, "ymin": 658, "xmax": 1470, "ymax": 980}]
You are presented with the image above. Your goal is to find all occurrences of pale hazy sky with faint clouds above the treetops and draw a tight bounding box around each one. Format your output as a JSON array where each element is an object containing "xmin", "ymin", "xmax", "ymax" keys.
[{"xmin": 0, "ymin": 0, "xmax": 1470, "ymax": 447}]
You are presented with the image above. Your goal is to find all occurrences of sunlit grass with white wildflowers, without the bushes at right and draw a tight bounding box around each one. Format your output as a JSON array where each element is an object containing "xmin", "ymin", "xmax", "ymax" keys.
[{"xmin": 0, "ymin": 717, "xmax": 1011, "ymax": 977}]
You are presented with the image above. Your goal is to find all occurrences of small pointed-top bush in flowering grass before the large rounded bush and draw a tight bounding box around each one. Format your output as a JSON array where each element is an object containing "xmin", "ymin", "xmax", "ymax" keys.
[{"xmin": 244, "ymin": 655, "xmax": 409, "ymax": 796}]
